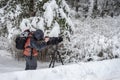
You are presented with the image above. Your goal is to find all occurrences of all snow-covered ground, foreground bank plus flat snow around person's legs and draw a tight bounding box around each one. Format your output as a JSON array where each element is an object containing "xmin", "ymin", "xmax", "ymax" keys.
[{"xmin": 0, "ymin": 50, "xmax": 120, "ymax": 80}]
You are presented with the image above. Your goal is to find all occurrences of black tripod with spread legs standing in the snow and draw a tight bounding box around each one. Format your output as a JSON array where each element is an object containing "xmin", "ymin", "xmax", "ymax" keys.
[{"xmin": 49, "ymin": 45, "xmax": 64, "ymax": 68}]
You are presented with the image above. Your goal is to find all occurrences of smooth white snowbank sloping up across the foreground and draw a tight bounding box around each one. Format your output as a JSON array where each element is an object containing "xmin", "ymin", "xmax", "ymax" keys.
[{"xmin": 0, "ymin": 59, "xmax": 120, "ymax": 80}]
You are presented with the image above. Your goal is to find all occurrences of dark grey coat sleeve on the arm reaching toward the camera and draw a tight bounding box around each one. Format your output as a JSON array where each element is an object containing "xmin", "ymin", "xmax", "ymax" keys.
[{"xmin": 30, "ymin": 38, "xmax": 47, "ymax": 51}]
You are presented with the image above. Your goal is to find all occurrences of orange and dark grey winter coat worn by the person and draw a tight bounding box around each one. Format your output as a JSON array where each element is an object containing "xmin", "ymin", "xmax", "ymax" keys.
[{"xmin": 23, "ymin": 34, "xmax": 47, "ymax": 56}]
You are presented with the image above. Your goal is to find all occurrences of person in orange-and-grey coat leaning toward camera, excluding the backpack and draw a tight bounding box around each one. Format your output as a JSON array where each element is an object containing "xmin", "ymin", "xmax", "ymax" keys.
[{"xmin": 23, "ymin": 29, "xmax": 49, "ymax": 70}]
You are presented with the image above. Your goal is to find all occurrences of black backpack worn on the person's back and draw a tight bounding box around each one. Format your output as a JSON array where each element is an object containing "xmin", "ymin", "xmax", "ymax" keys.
[{"xmin": 15, "ymin": 30, "xmax": 30, "ymax": 50}]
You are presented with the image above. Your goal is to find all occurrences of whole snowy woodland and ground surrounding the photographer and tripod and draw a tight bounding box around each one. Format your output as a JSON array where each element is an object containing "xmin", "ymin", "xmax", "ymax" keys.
[{"xmin": 0, "ymin": 0, "xmax": 120, "ymax": 80}]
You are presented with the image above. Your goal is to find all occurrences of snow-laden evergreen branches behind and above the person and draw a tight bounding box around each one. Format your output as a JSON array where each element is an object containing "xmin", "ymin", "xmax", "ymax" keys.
[{"xmin": 0, "ymin": 0, "xmax": 73, "ymax": 60}]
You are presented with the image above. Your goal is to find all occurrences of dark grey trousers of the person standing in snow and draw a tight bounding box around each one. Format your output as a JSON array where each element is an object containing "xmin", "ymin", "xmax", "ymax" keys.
[{"xmin": 25, "ymin": 56, "xmax": 37, "ymax": 70}]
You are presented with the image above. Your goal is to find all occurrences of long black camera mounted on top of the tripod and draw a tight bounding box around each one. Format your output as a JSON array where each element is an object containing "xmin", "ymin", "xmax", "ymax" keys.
[{"xmin": 47, "ymin": 37, "xmax": 63, "ymax": 45}]
